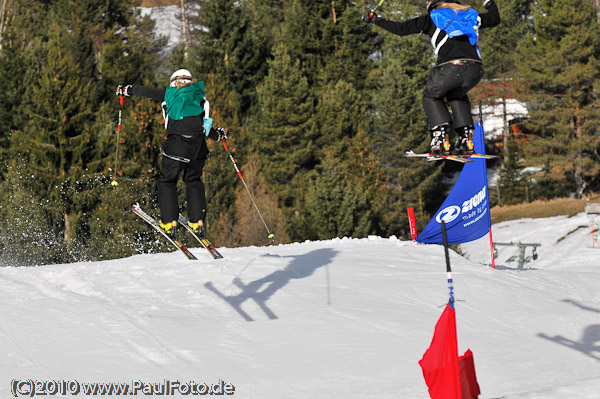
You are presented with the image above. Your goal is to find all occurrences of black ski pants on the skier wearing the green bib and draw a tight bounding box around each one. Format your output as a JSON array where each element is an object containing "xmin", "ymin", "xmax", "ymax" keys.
[{"xmin": 157, "ymin": 134, "xmax": 207, "ymax": 223}]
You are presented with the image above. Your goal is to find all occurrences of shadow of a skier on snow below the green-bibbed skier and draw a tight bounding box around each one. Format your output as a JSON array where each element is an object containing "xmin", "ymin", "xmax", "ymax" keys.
[{"xmin": 204, "ymin": 248, "xmax": 338, "ymax": 321}]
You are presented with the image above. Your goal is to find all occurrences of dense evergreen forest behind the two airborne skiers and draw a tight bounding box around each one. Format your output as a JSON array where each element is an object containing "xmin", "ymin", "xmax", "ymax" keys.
[{"xmin": 0, "ymin": 0, "xmax": 600, "ymax": 265}]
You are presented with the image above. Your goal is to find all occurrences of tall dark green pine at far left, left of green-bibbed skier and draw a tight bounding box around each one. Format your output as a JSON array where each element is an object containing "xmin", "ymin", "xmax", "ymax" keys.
[{"xmin": 12, "ymin": 7, "xmax": 97, "ymax": 260}]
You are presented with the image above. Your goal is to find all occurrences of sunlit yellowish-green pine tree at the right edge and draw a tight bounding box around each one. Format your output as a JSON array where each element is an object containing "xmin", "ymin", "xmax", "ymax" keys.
[{"xmin": 518, "ymin": 0, "xmax": 600, "ymax": 196}]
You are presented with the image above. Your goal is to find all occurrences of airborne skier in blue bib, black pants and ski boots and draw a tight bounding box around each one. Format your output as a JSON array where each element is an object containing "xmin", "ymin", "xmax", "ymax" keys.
[{"xmin": 362, "ymin": 0, "xmax": 500, "ymax": 155}]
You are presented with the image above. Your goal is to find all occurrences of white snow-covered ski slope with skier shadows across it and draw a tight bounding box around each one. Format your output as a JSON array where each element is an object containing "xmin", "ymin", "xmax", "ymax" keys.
[{"xmin": 0, "ymin": 215, "xmax": 600, "ymax": 399}]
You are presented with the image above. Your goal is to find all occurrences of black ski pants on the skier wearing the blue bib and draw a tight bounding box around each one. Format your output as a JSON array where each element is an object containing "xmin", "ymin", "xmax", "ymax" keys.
[{"xmin": 423, "ymin": 62, "xmax": 483, "ymax": 129}]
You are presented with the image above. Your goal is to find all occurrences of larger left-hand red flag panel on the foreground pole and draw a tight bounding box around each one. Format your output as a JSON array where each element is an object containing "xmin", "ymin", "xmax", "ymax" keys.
[{"xmin": 419, "ymin": 303, "xmax": 462, "ymax": 399}]
